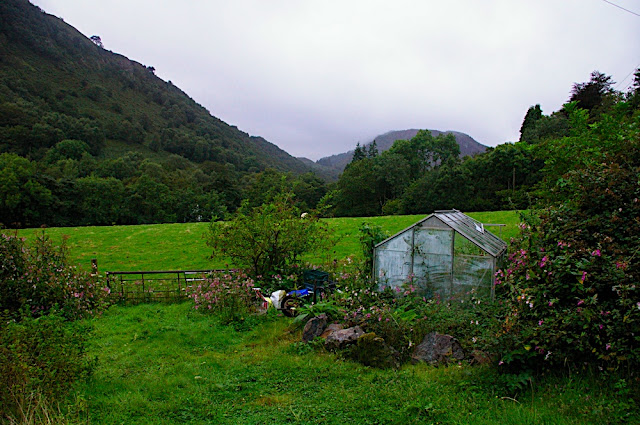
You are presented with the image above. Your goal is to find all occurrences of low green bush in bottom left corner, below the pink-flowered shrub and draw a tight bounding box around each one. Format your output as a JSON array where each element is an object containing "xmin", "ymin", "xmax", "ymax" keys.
[{"xmin": 0, "ymin": 312, "xmax": 92, "ymax": 421}]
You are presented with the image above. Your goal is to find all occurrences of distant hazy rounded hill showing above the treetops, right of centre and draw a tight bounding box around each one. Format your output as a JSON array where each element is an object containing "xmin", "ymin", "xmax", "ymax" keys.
[{"xmin": 317, "ymin": 129, "xmax": 487, "ymax": 172}]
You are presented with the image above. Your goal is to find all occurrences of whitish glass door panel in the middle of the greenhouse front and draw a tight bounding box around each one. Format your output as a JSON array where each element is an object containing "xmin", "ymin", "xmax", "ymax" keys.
[{"xmin": 413, "ymin": 228, "xmax": 454, "ymax": 295}]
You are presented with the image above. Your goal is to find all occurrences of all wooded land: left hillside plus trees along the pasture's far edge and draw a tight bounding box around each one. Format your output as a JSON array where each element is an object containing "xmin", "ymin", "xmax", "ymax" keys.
[{"xmin": 0, "ymin": 0, "xmax": 640, "ymax": 227}]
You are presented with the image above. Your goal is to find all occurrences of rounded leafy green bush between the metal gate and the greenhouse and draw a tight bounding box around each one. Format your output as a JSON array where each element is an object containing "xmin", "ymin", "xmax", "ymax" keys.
[{"xmin": 206, "ymin": 196, "xmax": 328, "ymax": 280}]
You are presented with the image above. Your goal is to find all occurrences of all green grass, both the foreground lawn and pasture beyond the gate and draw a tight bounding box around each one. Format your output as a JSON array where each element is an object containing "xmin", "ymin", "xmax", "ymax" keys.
[{"xmin": 10, "ymin": 211, "xmax": 638, "ymax": 425}]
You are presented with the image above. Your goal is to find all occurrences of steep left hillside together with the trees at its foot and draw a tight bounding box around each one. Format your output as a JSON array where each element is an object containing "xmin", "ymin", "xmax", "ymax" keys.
[{"xmin": 0, "ymin": 0, "xmax": 324, "ymax": 228}]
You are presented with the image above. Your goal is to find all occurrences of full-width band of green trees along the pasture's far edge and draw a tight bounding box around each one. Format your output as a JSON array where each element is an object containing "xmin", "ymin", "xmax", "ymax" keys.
[{"xmin": 0, "ymin": 68, "xmax": 640, "ymax": 227}]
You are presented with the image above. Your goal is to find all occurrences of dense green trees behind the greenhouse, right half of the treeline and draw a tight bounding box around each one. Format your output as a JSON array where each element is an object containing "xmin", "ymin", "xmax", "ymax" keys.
[{"xmin": 325, "ymin": 70, "xmax": 640, "ymax": 216}]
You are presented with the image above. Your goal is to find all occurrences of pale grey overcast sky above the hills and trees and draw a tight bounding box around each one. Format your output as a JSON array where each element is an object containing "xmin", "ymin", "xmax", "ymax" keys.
[{"xmin": 31, "ymin": 0, "xmax": 640, "ymax": 159}]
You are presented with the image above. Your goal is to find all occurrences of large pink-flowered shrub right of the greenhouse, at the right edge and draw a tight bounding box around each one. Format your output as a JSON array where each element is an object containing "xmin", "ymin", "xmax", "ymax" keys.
[{"xmin": 496, "ymin": 140, "xmax": 640, "ymax": 368}]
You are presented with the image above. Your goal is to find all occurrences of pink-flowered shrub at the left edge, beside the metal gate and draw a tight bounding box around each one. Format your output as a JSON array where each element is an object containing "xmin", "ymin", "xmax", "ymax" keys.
[{"xmin": 0, "ymin": 233, "xmax": 109, "ymax": 319}]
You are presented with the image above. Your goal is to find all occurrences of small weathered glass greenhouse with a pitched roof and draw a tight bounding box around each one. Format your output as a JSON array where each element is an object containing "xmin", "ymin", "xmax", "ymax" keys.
[{"xmin": 373, "ymin": 210, "xmax": 507, "ymax": 298}]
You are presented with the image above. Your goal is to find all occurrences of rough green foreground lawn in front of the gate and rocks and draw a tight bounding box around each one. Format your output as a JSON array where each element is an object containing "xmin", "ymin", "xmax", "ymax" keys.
[{"xmin": 77, "ymin": 303, "xmax": 631, "ymax": 425}]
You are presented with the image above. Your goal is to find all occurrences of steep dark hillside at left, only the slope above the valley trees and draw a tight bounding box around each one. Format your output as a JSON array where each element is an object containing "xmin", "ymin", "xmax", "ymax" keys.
[{"xmin": 0, "ymin": 0, "xmax": 308, "ymax": 173}]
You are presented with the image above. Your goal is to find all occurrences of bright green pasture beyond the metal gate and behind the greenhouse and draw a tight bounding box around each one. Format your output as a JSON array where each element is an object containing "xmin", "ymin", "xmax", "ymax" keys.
[{"xmin": 18, "ymin": 211, "xmax": 519, "ymax": 271}]
